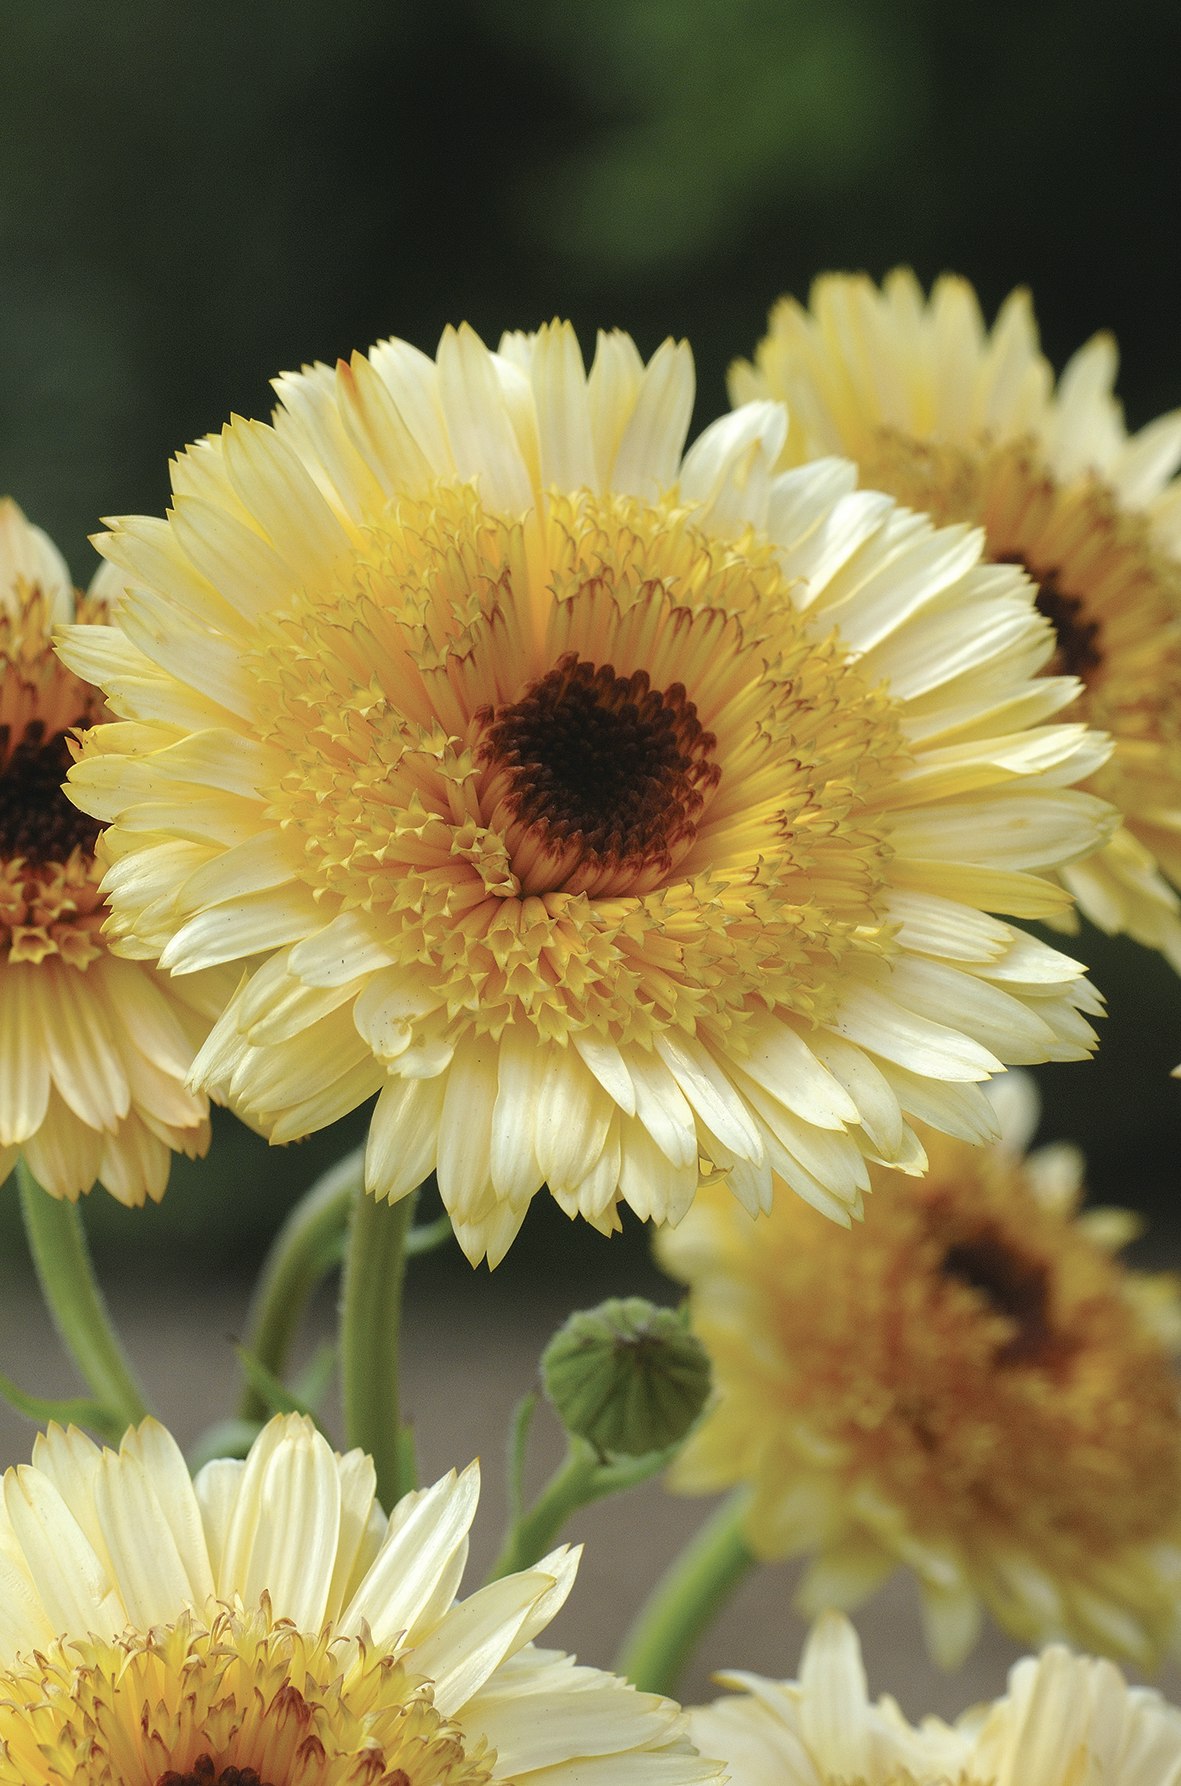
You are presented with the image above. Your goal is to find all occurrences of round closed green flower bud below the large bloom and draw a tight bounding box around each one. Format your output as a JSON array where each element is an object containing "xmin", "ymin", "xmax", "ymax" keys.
[{"xmin": 541, "ymin": 1297, "xmax": 709, "ymax": 1457}]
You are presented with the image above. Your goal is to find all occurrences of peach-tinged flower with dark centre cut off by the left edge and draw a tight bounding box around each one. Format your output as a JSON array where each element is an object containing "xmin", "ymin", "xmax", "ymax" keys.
[{"xmin": 0, "ymin": 500, "xmax": 209, "ymax": 1204}]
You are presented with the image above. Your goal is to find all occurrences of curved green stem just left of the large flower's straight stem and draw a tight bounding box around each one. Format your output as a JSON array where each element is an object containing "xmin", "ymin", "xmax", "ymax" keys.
[{"xmin": 238, "ymin": 1147, "xmax": 364, "ymax": 1420}]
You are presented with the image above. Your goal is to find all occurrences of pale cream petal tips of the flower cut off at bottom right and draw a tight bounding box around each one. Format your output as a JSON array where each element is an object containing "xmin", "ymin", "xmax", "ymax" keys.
[{"xmin": 688, "ymin": 1613, "xmax": 1181, "ymax": 1786}]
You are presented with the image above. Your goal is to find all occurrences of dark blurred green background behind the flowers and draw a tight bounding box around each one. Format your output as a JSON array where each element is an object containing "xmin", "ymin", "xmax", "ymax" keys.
[{"xmin": 0, "ymin": 0, "xmax": 1181, "ymax": 1279}]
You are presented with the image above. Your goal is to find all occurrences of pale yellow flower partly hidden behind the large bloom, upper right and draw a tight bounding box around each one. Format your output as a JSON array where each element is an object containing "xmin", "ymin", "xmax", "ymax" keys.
[{"xmin": 731, "ymin": 270, "xmax": 1181, "ymax": 972}]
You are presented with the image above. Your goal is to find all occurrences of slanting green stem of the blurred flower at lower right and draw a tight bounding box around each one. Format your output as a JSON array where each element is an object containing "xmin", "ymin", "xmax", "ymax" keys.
[{"xmin": 615, "ymin": 1491, "xmax": 754, "ymax": 1695}]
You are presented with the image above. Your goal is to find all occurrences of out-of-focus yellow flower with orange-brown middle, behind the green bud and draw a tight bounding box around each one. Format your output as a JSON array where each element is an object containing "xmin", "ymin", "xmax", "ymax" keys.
[{"xmin": 659, "ymin": 1075, "xmax": 1181, "ymax": 1666}]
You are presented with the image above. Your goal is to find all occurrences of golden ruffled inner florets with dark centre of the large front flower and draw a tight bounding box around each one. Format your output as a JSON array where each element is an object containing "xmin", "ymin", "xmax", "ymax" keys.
[{"xmin": 252, "ymin": 486, "xmax": 908, "ymax": 1041}]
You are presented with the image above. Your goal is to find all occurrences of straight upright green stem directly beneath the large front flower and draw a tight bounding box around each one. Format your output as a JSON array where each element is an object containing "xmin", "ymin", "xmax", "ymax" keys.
[{"xmin": 339, "ymin": 1189, "xmax": 418, "ymax": 1509}]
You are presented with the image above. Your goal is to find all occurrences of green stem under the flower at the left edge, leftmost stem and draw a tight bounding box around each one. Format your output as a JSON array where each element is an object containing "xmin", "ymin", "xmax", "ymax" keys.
[{"xmin": 16, "ymin": 1154, "xmax": 148, "ymax": 1427}]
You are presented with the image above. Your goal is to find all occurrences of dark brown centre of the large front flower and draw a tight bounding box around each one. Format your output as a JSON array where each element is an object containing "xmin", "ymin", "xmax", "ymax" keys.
[{"xmin": 481, "ymin": 652, "xmax": 722, "ymax": 893}]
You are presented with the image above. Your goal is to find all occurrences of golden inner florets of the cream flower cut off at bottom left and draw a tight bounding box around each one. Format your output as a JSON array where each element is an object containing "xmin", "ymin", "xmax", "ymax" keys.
[{"xmin": 0, "ymin": 1600, "xmax": 495, "ymax": 1786}]
